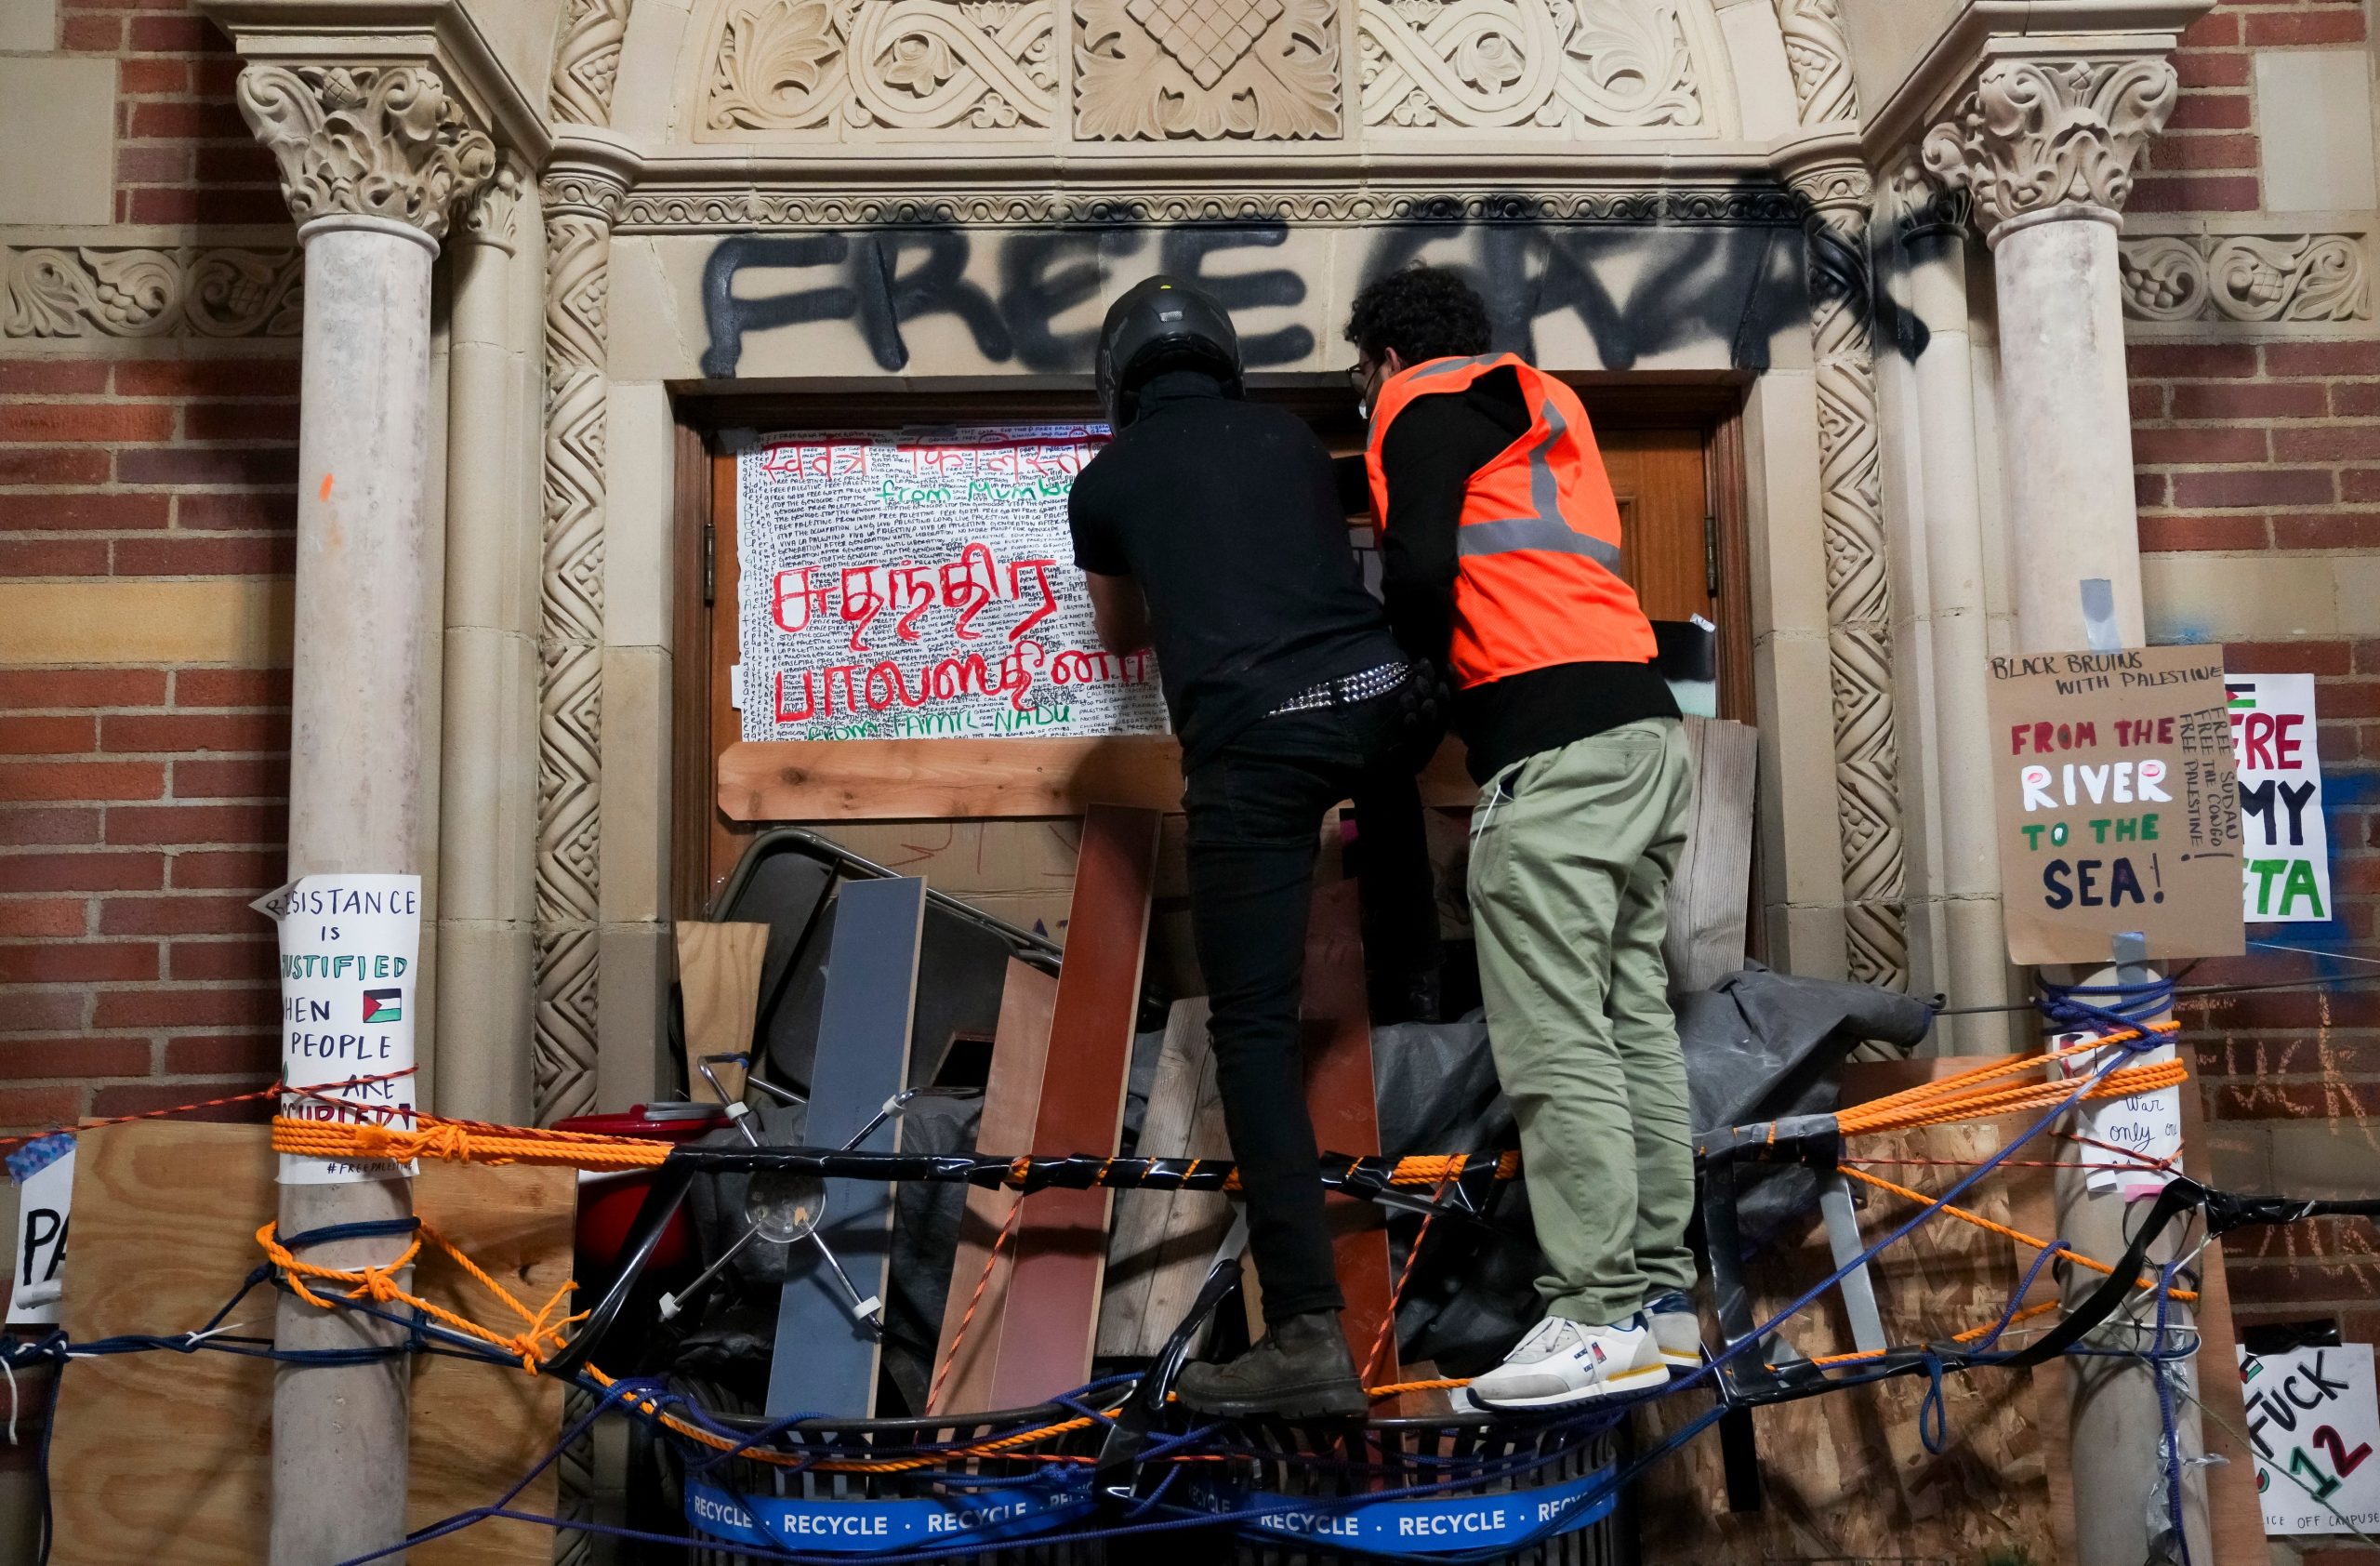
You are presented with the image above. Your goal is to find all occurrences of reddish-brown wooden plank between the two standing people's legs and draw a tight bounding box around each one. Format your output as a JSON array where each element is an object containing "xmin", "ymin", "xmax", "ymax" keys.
[{"xmin": 1304, "ymin": 881, "xmax": 1402, "ymax": 1385}]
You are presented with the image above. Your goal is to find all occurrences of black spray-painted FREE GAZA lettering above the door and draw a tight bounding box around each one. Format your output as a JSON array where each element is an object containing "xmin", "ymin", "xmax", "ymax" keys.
[{"xmin": 702, "ymin": 221, "xmax": 1804, "ymax": 378}]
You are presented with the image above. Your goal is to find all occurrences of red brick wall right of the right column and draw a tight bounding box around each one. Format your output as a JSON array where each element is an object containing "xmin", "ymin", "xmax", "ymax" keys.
[{"xmin": 2130, "ymin": 0, "xmax": 2380, "ymax": 1437}]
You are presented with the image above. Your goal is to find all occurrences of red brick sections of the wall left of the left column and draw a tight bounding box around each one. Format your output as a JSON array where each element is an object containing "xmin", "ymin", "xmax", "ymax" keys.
[{"xmin": 0, "ymin": 0, "xmax": 298, "ymax": 1131}]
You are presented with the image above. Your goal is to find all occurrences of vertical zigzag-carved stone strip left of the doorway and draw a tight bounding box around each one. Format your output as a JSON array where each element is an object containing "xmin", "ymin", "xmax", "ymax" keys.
[{"xmin": 533, "ymin": 181, "xmax": 619, "ymax": 1123}]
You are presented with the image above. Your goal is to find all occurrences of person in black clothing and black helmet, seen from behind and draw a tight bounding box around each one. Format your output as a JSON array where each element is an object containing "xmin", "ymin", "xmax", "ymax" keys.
[{"xmin": 1068, "ymin": 278, "xmax": 1437, "ymax": 1416}]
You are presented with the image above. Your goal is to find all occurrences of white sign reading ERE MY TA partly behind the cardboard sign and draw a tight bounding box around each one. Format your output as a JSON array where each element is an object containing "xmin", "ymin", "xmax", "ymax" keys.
[{"xmin": 2223, "ymin": 673, "xmax": 2330, "ymax": 923}]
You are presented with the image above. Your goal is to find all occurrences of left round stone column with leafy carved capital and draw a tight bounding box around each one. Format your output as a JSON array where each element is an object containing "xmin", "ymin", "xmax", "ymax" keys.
[{"xmin": 238, "ymin": 64, "xmax": 495, "ymax": 1566}]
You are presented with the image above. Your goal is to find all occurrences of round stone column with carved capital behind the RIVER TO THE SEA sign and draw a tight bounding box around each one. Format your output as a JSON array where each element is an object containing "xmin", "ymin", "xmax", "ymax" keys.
[{"xmin": 1923, "ymin": 51, "xmax": 2230, "ymax": 1566}]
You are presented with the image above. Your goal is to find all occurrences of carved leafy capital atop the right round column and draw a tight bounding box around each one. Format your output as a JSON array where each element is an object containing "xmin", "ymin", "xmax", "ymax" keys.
[{"xmin": 1923, "ymin": 60, "xmax": 2177, "ymax": 235}]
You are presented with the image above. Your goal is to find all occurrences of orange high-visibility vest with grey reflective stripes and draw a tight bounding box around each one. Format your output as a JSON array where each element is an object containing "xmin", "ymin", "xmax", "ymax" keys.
[{"xmin": 1364, "ymin": 354, "xmax": 1654, "ymax": 688}]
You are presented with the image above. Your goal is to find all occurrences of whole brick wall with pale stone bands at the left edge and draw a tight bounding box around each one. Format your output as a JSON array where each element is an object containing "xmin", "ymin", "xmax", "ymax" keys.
[{"xmin": 0, "ymin": 0, "xmax": 298, "ymax": 1147}]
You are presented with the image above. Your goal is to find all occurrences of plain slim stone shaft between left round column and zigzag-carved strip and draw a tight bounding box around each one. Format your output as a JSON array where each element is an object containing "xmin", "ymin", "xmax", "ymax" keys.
[{"xmin": 433, "ymin": 154, "xmax": 538, "ymax": 1123}]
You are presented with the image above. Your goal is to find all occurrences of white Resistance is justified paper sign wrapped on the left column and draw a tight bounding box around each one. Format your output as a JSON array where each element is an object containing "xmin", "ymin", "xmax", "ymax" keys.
[{"xmin": 250, "ymin": 873, "xmax": 421, "ymax": 1186}]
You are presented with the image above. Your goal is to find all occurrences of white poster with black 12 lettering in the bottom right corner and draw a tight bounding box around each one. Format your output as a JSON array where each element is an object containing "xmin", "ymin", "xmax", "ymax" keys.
[{"xmin": 2240, "ymin": 1342, "xmax": 2380, "ymax": 1535}]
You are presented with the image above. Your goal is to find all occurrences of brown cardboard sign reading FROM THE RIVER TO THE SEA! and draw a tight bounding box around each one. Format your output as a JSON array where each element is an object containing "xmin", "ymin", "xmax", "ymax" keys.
[{"xmin": 1990, "ymin": 647, "xmax": 2244, "ymax": 964}]
